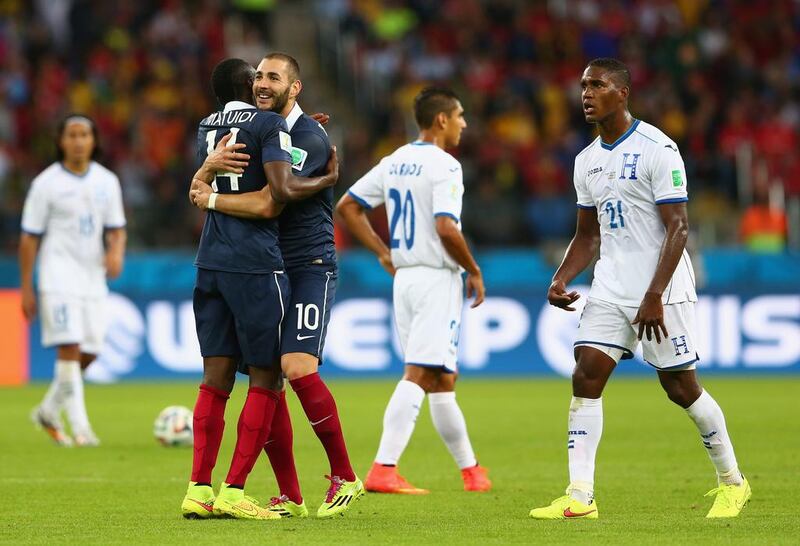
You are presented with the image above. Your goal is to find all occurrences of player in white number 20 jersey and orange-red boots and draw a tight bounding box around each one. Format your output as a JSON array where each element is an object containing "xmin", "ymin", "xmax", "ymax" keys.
[{"xmin": 337, "ymin": 88, "xmax": 491, "ymax": 494}]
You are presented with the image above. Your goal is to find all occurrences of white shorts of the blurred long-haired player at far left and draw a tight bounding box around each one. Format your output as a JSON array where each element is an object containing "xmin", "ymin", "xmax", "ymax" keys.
[{"xmin": 39, "ymin": 293, "xmax": 107, "ymax": 355}]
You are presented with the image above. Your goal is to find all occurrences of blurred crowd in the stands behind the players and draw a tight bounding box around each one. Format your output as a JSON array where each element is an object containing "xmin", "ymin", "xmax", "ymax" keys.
[{"xmin": 0, "ymin": 0, "xmax": 800, "ymax": 253}]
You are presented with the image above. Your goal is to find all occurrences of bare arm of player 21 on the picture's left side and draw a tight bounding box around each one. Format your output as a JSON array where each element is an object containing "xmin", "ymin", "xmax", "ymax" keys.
[{"xmin": 547, "ymin": 207, "xmax": 600, "ymax": 311}]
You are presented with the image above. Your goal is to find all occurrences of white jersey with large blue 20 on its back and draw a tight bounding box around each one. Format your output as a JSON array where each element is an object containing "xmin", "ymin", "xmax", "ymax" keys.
[{"xmin": 349, "ymin": 140, "xmax": 464, "ymax": 270}]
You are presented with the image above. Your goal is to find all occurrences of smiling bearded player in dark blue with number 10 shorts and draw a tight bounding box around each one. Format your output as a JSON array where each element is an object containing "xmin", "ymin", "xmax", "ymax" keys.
[{"xmin": 189, "ymin": 53, "xmax": 363, "ymax": 517}]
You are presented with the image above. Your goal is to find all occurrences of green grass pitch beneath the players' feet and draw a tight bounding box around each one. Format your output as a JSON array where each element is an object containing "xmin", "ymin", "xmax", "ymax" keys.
[{"xmin": 0, "ymin": 376, "xmax": 800, "ymax": 545}]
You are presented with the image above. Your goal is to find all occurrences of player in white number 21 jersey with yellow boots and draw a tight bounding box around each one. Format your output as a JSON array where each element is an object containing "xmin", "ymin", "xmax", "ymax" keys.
[{"xmin": 530, "ymin": 58, "xmax": 750, "ymax": 519}]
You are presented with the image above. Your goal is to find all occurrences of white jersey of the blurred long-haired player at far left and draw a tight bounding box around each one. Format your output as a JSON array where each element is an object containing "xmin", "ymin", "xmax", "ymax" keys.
[{"xmin": 22, "ymin": 161, "xmax": 125, "ymax": 296}]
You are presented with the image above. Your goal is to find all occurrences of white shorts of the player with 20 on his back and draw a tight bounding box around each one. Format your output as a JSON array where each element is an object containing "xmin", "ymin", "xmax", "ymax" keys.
[{"xmin": 394, "ymin": 266, "xmax": 464, "ymax": 373}]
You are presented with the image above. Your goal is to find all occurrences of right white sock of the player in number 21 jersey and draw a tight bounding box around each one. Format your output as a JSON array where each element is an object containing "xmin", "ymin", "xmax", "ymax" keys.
[{"xmin": 686, "ymin": 390, "xmax": 742, "ymax": 485}]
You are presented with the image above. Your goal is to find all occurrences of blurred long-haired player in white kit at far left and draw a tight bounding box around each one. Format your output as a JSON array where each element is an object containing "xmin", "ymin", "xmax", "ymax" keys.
[{"xmin": 19, "ymin": 115, "xmax": 126, "ymax": 446}]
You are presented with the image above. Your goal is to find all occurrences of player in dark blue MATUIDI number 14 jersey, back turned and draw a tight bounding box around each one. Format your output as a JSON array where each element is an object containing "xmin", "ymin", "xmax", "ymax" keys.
[{"xmin": 181, "ymin": 59, "xmax": 338, "ymax": 519}]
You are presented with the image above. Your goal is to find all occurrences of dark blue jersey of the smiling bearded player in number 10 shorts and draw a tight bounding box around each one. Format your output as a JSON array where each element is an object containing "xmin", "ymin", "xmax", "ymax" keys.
[{"xmin": 279, "ymin": 114, "xmax": 336, "ymax": 267}]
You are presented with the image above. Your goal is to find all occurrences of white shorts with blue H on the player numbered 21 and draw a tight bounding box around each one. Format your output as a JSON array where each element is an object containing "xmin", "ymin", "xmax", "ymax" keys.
[{"xmin": 575, "ymin": 299, "xmax": 700, "ymax": 371}]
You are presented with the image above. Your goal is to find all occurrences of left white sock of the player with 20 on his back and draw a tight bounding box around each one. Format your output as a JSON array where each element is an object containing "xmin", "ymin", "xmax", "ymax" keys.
[{"xmin": 375, "ymin": 379, "xmax": 425, "ymax": 464}]
